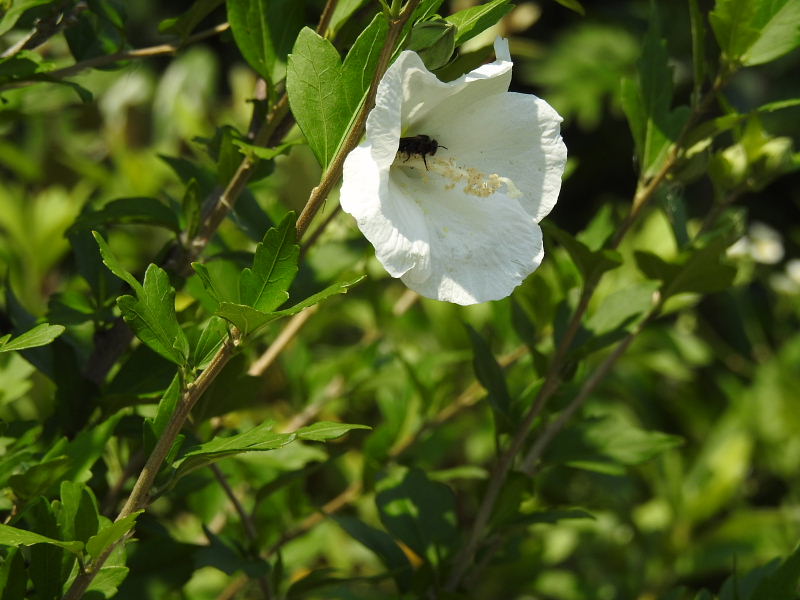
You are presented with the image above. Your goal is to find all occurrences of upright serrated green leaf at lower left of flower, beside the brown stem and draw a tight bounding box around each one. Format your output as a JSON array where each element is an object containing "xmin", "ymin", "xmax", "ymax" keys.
[{"xmin": 239, "ymin": 212, "xmax": 300, "ymax": 313}]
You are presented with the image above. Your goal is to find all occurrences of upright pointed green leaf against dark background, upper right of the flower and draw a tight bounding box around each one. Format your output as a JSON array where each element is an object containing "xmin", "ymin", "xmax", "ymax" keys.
[{"xmin": 621, "ymin": 14, "xmax": 690, "ymax": 178}]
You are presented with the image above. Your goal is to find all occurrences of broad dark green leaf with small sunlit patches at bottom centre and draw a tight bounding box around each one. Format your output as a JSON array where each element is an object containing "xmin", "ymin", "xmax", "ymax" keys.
[{"xmin": 375, "ymin": 469, "xmax": 459, "ymax": 564}]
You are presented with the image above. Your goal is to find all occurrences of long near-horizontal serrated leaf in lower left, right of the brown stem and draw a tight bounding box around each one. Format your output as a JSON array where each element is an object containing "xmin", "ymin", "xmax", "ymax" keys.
[{"xmin": 174, "ymin": 422, "xmax": 297, "ymax": 478}]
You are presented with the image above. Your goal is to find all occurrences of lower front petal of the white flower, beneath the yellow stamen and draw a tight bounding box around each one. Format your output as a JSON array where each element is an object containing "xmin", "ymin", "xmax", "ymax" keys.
[{"xmin": 389, "ymin": 168, "xmax": 544, "ymax": 304}]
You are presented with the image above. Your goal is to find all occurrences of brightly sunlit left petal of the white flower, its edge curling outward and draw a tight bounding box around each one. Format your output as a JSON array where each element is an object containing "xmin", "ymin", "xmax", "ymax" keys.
[{"xmin": 339, "ymin": 143, "xmax": 429, "ymax": 277}]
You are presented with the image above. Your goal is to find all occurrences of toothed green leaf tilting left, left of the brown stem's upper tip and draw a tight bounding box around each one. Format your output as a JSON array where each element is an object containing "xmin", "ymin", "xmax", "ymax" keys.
[{"xmin": 117, "ymin": 264, "xmax": 189, "ymax": 366}]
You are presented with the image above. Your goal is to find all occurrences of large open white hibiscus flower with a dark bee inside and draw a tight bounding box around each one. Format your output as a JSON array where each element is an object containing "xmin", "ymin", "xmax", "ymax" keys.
[{"xmin": 341, "ymin": 38, "xmax": 567, "ymax": 304}]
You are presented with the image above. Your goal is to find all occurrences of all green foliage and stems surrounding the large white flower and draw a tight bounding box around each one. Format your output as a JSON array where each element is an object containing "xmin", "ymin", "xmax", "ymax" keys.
[{"xmin": 0, "ymin": 0, "xmax": 800, "ymax": 600}]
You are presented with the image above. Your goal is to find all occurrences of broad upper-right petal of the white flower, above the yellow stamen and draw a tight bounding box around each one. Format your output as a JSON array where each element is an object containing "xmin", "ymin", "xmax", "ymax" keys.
[{"xmin": 418, "ymin": 92, "xmax": 567, "ymax": 222}]
